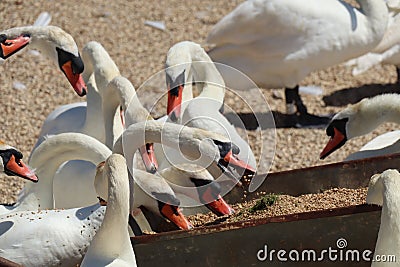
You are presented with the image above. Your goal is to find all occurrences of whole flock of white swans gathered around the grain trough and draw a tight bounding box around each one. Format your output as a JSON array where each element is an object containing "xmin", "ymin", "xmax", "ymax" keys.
[{"xmin": 0, "ymin": 0, "xmax": 400, "ymax": 266}]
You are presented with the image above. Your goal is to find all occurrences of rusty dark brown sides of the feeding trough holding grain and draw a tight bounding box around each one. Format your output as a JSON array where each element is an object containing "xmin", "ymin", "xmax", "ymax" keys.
[{"xmin": 132, "ymin": 155, "xmax": 400, "ymax": 267}]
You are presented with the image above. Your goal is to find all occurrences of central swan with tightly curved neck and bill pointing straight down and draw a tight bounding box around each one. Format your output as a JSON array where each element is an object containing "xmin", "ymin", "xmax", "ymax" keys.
[{"xmin": 160, "ymin": 41, "xmax": 257, "ymax": 173}]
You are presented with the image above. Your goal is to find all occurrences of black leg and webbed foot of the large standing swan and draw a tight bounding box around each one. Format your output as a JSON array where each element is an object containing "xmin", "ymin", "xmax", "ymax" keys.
[{"xmin": 285, "ymin": 85, "xmax": 331, "ymax": 128}]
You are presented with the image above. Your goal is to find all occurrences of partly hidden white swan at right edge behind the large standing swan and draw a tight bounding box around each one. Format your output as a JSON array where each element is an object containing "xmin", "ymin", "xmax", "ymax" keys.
[{"xmin": 346, "ymin": 2, "xmax": 400, "ymax": 79}]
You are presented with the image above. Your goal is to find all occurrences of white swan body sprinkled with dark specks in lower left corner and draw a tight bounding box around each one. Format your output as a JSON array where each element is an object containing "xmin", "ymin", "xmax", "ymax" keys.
[{"xmin": 0, "ymin": 204, "xmax": 105, "ymax": 267}]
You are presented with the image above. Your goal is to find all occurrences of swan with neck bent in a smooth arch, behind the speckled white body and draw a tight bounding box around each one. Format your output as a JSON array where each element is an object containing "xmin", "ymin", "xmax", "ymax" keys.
[{"xmin": 0, "ymin": 133, "xmax": 111, "ymax": 214}]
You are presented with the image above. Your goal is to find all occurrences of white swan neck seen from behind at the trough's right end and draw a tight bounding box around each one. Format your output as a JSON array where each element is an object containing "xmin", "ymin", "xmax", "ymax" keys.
[{"xmin": 366, "ymin": 169, "xmax": 400, "ymax": 267}]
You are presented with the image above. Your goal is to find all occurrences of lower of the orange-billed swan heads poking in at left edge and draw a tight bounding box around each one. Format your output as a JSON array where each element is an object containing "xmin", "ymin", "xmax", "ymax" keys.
[{"xmin": 0, "ymin": 142, "xmax": 39, "ymax": 183}]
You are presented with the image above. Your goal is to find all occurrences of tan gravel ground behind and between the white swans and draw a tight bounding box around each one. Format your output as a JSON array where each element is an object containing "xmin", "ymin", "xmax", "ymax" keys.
[{"xmin": 0, "ymin": 0, "xmax": 397, "ymax": 207}]
